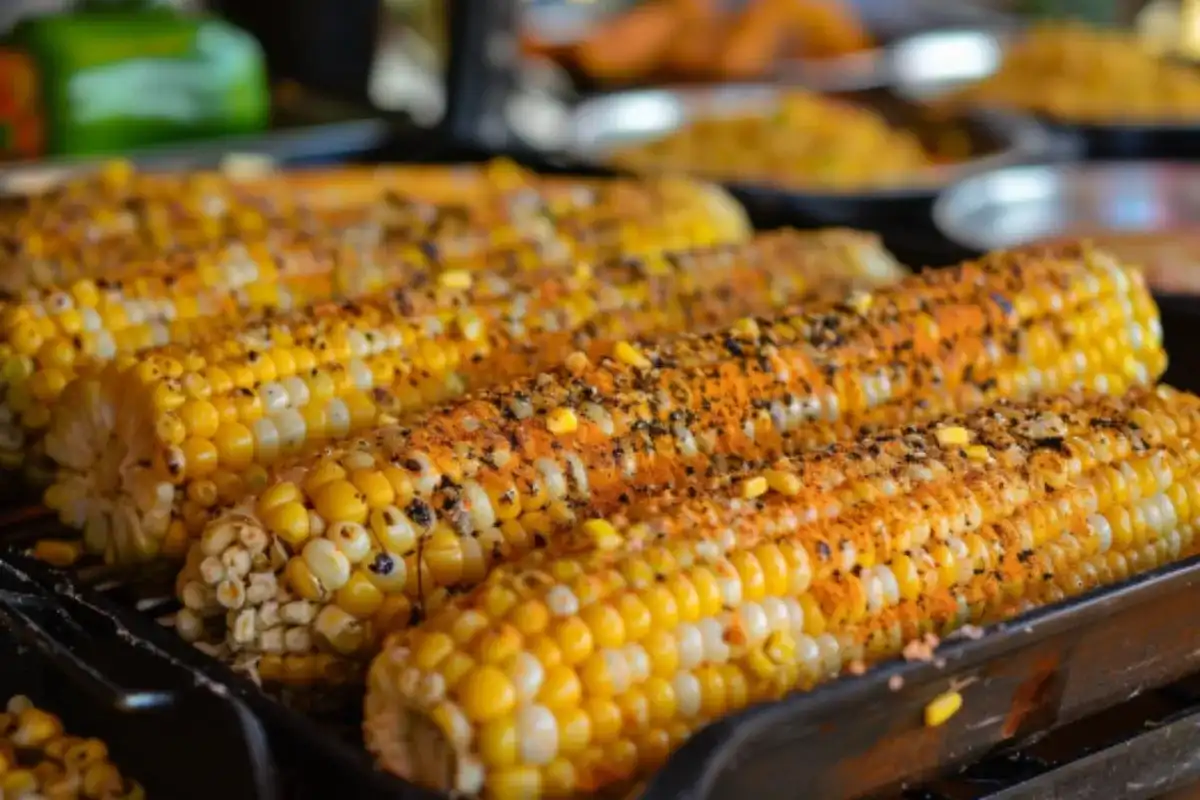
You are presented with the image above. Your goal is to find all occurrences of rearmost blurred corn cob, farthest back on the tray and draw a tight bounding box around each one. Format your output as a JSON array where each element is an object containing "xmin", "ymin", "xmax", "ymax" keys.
[{"xmin": 0, "ymin": 157, "xmax": 750, "ymax": 294}]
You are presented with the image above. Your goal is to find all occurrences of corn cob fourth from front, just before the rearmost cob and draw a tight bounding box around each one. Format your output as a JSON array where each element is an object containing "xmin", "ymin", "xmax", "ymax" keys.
[{"xmin": 9, "ymin": 167, "xmax": 753, "ymax": 485}]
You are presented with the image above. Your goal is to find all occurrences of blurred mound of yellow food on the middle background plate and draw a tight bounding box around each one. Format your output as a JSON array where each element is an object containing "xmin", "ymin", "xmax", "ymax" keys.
[{"xmin": 610, "ymin": 91, "xmax": 936, "ymax": 191}]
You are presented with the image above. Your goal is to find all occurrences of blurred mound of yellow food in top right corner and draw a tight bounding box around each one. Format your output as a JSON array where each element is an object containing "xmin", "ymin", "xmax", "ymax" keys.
[{"xmin": 953, "ymin": 24, "xmax": 1200, "ymax": 124}]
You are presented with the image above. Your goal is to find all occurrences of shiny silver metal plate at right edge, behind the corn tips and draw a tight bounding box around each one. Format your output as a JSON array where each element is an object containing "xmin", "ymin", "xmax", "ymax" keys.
[{"xmin": 934, "ymin": 162, "xmax": 1200, "ymax": 251}]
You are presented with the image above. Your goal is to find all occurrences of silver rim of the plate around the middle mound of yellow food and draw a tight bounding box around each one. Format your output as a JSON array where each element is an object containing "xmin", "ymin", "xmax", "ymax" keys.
[{"xmin": 563, "ymin": 84, "xmax": 1056, "ymax": 199}]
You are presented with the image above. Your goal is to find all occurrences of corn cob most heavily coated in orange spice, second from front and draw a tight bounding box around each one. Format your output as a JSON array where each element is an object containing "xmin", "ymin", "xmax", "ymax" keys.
[{"xmin": 178, "ymin": 244, "xmax": 1165, "ymax": 678}]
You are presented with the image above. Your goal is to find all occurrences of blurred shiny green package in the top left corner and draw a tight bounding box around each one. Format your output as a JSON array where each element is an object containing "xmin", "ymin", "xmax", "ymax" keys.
[{"xmin": 0, "ymin": 2, "xmax": 270, "ymax": 156}]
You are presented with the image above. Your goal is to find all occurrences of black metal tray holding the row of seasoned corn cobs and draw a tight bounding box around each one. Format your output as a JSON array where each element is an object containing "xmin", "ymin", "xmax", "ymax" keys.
[{"xmin": 7, "ymin": 523, "xmax": 1200, "ymax": 800}]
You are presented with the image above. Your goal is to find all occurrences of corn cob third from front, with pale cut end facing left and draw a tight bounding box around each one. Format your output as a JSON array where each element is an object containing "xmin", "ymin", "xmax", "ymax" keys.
[{"xmin": 47, "ymin": 234, "xmax": 896, "ymax": 561}]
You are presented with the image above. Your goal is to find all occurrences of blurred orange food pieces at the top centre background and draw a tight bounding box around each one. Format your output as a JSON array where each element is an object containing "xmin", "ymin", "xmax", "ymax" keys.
[{"xmin": 523, "ymin": 0, "xmax": 872, "ymax": 84}]
